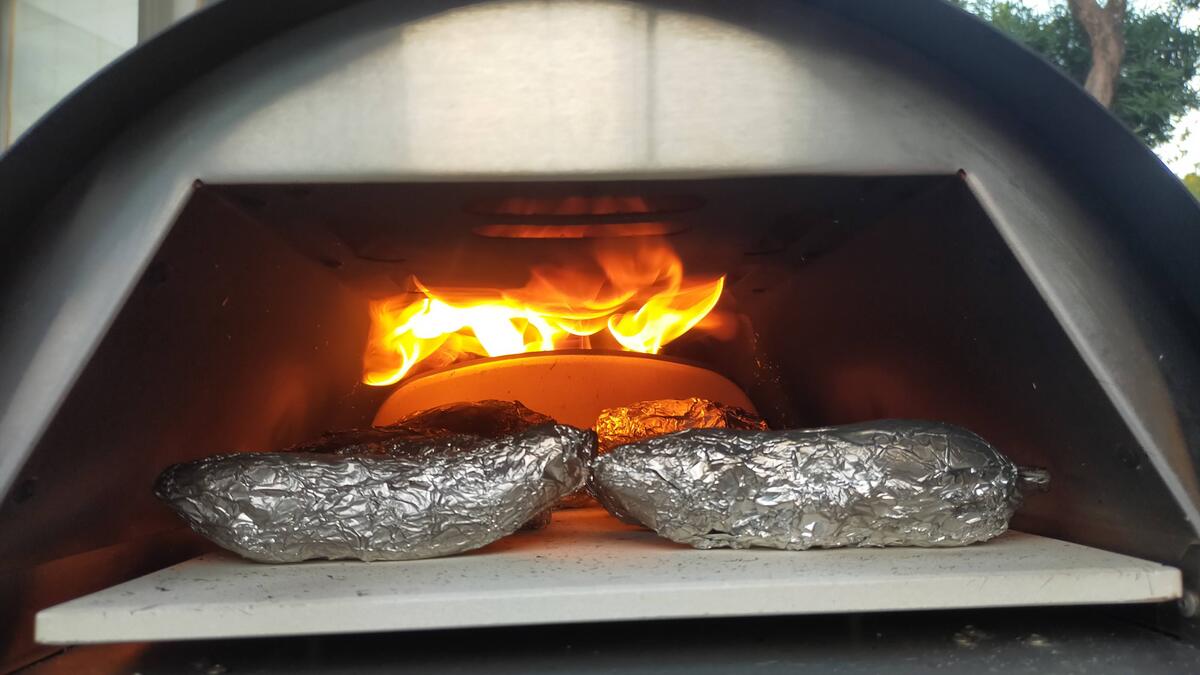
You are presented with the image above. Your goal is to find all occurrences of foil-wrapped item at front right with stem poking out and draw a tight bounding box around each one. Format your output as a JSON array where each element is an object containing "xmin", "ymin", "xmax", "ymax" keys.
[{"xmin": 592, "ymin": 420, "xmax": 1046, "ymax": 550}]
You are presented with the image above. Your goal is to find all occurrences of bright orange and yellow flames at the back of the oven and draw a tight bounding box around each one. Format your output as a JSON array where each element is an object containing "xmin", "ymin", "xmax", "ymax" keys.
[{"xmin": 362, "ymin": 241, "xmax": 725, "ymax": 386}]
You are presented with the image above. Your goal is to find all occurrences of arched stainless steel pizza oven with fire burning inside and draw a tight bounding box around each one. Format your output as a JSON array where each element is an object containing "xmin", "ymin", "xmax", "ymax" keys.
[{"xmin": 0, "ymin": 0, "xmax": 1200, "ymax": 671}]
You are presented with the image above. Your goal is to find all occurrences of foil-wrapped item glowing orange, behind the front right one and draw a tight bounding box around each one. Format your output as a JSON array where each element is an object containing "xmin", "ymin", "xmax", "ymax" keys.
[{"xmin": 595, "ymin": 398, "xmax": 767, "ymax": 453}]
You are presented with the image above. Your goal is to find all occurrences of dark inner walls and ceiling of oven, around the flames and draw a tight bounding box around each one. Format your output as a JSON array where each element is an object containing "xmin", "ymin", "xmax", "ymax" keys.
[{"xmin": 0, "ymin": 174, "xmax": 1192, "ymax": 653}]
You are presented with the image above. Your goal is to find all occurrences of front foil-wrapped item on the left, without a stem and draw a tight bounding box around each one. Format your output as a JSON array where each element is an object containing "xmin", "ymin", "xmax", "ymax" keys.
[{"xmin": 155, "ymin": 424, "xmax": 595, "ymax": 562}]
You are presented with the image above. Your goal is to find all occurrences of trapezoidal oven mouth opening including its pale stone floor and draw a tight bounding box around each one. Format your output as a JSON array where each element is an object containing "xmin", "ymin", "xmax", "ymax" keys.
[{"xmin": 23, "ymin": 174, "xmax": 1182, "ymax": 643}]
